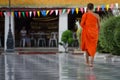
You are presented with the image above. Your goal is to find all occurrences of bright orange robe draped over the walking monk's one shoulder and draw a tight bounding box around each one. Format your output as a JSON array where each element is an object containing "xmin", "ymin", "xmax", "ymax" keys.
[{"xmin": 80, "ymin": 12, "xmax": 98, "ymax": 57}]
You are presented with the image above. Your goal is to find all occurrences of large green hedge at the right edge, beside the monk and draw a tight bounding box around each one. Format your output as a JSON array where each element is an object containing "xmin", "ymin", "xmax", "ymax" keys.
[{"xmin": 98, "ymin": 15, "xmax": 120, "ymax": 55}]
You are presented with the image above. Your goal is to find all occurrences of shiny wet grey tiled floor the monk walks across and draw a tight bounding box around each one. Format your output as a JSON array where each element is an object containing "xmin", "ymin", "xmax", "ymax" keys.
[{"xmin": 0, "ymin": 53, "xmax": 120, "ymax": 80}]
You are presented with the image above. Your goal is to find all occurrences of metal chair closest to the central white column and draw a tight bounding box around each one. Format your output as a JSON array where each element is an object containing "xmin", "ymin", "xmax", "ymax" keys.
[{"xmin": 49, "ymin": 32, "xmax": 58, "ymax": 47}]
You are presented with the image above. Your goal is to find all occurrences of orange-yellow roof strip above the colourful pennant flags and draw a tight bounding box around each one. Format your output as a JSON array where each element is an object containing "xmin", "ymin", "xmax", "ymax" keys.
[{"xmin": 0, "ymin": 0, "xmax": 120, "ymax": 8}]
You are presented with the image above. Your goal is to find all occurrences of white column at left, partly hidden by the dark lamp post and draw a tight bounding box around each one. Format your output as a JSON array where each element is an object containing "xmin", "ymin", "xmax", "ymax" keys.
[{"xmin": 4, "ymin": 12, "xmax": 14, "ymax": 51}]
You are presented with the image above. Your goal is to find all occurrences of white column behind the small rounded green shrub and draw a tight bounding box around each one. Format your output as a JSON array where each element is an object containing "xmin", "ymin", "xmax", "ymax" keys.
[{"xmin": 58, "ymin": 13, "xmax": 68, "ymax": 51}]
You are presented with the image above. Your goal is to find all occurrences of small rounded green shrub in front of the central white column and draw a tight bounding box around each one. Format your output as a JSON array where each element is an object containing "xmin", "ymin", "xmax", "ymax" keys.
[{"xmin": 59, "ymin": 30, "xmax": 74, "ymax": 52}]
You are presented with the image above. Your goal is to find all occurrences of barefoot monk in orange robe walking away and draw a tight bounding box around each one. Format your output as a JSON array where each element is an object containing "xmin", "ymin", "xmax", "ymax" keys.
[{"xmin": 80, "ymin": 3, "xmax": 100, "ymax": 66}]
